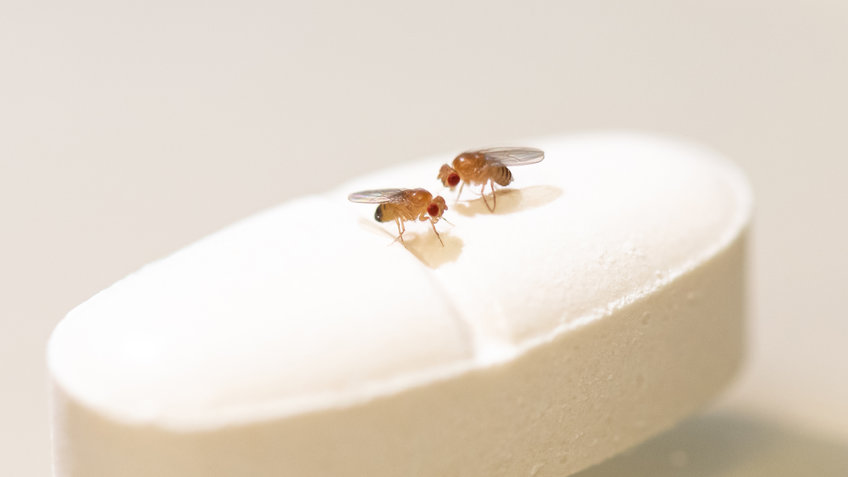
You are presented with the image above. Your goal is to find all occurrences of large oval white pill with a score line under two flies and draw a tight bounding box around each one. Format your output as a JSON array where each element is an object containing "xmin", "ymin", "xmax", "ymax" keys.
[{"xmin": 48, "ymin": 134, "xmax": 751, "ymax": 477}]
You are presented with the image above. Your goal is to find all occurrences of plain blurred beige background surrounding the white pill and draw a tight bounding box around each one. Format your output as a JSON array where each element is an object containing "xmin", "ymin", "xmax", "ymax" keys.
[{"xmin": 0, "ymin": 0, "xmax": 848, "ymax": 477}]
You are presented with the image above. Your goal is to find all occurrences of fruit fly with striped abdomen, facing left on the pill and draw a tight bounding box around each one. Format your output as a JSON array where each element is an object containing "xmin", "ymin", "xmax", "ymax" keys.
[{"xmin": 438, "ymin": 147, "xmax": 545, "ymax": 212}]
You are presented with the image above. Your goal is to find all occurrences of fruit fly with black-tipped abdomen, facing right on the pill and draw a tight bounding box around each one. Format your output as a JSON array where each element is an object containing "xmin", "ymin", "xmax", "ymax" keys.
[{"xmin": 347, "ymin": 189, "xmax": 448, "ymax": 247}]
